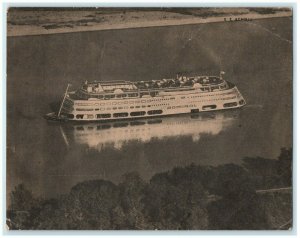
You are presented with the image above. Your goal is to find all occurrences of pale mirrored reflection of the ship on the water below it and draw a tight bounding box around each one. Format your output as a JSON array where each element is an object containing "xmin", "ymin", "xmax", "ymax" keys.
[{"xmin": 61, "ymin": 110, "xmax": 239, "ymax": 151}]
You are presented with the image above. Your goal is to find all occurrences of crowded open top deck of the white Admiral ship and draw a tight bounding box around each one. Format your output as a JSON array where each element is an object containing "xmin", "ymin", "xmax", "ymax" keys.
[{"xmin": 70, "ymin": 76, "xmax": 229, "ymax": 100}]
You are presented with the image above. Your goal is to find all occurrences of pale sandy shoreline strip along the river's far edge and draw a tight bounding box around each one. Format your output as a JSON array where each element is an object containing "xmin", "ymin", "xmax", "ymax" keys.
[{"xmin": 7, "ymin": 12, "xmax": 292, "ymax": 37}]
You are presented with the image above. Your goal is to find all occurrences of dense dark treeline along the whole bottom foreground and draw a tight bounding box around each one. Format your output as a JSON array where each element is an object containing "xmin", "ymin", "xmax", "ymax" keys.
[{"xmin": 7, "ymin": 149, "xmax": 292, "ymax": 230}]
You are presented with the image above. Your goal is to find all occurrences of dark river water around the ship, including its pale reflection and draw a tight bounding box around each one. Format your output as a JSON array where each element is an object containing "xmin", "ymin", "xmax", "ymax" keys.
[{"xmin": 7, "ymin": 18, "xmax": 293, "ymax": 197}]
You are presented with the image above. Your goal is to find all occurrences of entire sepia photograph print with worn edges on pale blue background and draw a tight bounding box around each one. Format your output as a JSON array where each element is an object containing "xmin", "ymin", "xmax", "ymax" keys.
[{"xmin": 3, "ymin": 4, "xmax": 295, "ymax": 232}]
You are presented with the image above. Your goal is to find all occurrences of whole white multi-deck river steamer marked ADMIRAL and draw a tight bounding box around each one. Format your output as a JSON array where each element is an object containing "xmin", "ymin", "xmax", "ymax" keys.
[{"xmin": 46, "ymin": 72, "xmax": 246, "ymax": 121}]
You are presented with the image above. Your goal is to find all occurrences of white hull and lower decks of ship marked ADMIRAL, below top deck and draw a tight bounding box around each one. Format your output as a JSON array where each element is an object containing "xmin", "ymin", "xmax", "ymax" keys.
[{"xmin": 45, "ymin": 84, "xmax": 246, "ymax": 122}]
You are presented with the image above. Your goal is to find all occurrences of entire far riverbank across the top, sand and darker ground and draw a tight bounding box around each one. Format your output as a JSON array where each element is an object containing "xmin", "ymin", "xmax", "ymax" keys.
[{"xmin": 7, "ymin": 8, "xmax": 292, "ymax": 36}]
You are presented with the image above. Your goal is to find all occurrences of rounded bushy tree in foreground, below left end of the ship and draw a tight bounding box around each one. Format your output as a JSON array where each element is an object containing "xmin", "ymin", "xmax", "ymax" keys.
[{"xmin": 63, "ymin": 180, "xmax": 119, "ymax": 230}]
